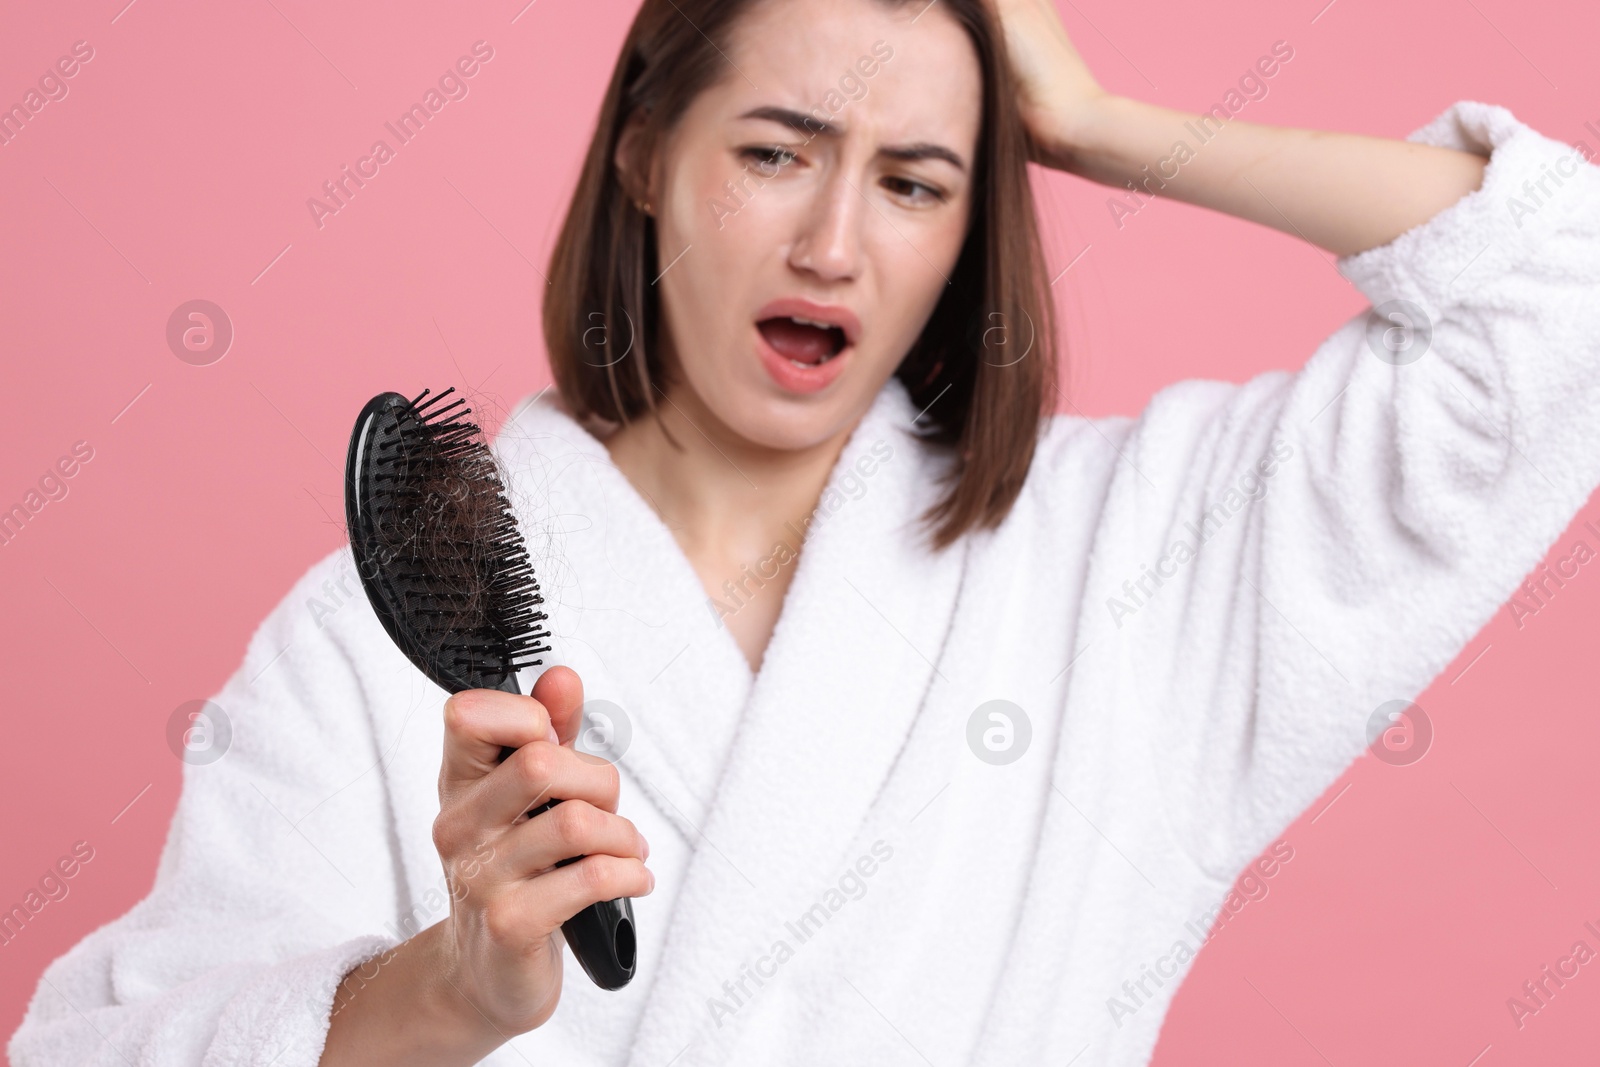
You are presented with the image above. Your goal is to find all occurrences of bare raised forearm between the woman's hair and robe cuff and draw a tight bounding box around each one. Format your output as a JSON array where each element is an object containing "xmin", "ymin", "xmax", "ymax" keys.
[{"xmin": 1035, "ymin": 94, "xmax": 1485, "ymax": 256}]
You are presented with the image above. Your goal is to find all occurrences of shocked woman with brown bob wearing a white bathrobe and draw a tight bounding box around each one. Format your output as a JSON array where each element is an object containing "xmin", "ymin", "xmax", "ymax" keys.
[{"xmin": 11, "ymin": 0, "xmax": 1600, "ymax": 1067}]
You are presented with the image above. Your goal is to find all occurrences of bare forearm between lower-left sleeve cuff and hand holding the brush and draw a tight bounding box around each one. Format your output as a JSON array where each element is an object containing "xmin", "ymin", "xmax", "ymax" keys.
[{"xmin": 320, "ymin": 923, "xmax": 506, "ymax": 1067}]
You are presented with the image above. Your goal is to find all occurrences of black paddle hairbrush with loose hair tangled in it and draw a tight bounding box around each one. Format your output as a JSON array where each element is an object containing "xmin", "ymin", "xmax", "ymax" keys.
[{"xmin": 344, "ymin": 389, "xmax": 635, "ymax": 989}]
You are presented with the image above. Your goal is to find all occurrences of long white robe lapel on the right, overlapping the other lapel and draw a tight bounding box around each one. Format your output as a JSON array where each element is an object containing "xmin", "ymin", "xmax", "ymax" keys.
[{"xmin": 629, "ymin": 379, "xmax": 965, "ymax": 1067}]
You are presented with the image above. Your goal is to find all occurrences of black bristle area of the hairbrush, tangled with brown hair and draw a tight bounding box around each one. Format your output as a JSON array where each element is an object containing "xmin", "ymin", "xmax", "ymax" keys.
[{"xmin": 373, "ymin": 389, "xmax": 550, "ymax": 685}]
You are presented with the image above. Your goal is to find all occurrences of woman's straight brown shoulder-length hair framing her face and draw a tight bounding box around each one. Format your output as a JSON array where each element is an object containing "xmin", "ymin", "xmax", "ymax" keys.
[{"xmin": 544, "ymin": 0, "xmax": 1056, "ymax": 549}]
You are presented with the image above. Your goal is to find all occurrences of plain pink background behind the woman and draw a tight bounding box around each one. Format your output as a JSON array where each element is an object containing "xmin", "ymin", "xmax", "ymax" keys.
[{"xmin": 0, "ymin": 0, "xmax": 1600, "ymax": 1067}]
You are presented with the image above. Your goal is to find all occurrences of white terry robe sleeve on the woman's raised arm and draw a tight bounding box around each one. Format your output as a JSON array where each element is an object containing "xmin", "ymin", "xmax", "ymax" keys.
[{"xmin": 1080, "ymin": 102, "xmax": 1600, "ymax": 880}]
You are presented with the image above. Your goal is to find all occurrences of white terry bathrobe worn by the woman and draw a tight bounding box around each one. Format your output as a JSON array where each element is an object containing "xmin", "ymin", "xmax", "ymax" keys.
[{"xmin": 11, "ymin": 104, "xmax": 1600, "ymax": 1067}]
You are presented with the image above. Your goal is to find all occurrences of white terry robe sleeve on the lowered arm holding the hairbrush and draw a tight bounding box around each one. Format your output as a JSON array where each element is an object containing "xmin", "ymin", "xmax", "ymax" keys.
[{"xmin": 10, "ymin": 550, "xmax": 406, "ymax": 1067}]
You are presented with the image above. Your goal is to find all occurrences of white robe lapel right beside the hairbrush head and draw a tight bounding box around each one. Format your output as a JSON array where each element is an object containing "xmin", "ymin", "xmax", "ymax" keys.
[{"xmin": 496, "ymin": 403, "xmax": 752, "ymax": 840}]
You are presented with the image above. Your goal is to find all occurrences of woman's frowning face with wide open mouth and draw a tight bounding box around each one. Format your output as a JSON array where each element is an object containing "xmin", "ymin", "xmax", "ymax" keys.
[{"xmin": 630, "ymin": 0, "xmax": 982, "ymax": 450}]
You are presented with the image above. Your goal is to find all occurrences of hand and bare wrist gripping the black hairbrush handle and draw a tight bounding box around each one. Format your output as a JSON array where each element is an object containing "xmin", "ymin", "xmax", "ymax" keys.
[{"xmin": 322, "ymin": 667, "xmax": 654, "ymax": 1067}]
